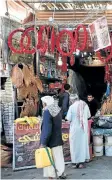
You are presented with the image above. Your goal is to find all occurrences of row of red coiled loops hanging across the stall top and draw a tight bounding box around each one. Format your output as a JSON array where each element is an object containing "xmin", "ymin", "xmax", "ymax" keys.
[{"xmin": 8, "ymin": 25, "xmax": 87, "ymax": 56}]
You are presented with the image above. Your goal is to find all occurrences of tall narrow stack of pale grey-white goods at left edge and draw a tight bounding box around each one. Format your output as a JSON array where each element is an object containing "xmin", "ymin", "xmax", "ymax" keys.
[{"xmin": 1, "ymin": 78, "xmax": 15, "ymax": 143}]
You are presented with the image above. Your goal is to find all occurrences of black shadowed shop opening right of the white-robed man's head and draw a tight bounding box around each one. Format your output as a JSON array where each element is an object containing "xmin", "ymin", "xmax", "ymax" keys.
[{"xmin": 79, "ymin": 66, "xmax": 106, "ymax": 102}]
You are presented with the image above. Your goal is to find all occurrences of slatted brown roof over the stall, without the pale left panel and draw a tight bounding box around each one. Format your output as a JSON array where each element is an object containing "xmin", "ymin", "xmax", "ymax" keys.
[{"xmin": 22, "ymin": 0, "xmax": 112, "ymax": 27}]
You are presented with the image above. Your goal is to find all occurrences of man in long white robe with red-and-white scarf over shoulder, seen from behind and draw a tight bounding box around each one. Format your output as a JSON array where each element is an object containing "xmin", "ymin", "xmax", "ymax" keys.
[{"xmin": 66, "ymin": 94, "xmax": 91, "ymax": 168}]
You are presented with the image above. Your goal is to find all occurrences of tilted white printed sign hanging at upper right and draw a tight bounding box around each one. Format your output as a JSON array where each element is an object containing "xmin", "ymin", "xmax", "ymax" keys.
[{"xmin": 89, "ymin": 16, "xmax": 111, "ymax": 52}]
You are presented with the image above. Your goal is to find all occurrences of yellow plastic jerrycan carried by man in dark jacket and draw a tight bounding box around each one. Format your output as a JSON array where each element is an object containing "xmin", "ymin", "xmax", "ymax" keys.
[{"xmin": 35, "ymin": 148, "xmax": 53, "ymax": 168}]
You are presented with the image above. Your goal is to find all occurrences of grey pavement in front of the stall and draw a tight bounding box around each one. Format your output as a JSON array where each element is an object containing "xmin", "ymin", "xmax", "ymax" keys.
[{"xmin": 1, "ymin": 156, "xmax": 112, "ymax": 180}]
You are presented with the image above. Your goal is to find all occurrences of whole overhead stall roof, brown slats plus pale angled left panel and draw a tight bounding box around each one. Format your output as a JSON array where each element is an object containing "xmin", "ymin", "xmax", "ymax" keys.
[{"xmin": 0, "ymin": 0, "xmax": 112, "ymax": 27}]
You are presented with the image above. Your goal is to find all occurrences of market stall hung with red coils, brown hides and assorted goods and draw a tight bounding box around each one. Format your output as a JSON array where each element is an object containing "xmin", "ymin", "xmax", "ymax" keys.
[{"xmin": 0, "ymin": 1, "xmax": 112, "ymax": 170}]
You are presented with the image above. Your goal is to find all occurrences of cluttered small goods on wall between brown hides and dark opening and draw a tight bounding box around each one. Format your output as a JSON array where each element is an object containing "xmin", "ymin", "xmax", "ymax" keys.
[{"xmin": 39, "ymin": 54, "xmax": 67, "ymax": 95}]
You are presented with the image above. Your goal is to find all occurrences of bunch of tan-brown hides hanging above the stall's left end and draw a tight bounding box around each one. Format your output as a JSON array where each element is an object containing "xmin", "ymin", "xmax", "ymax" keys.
[{"xmin": 11, "ymin": 63, "xmax": 43, "ymax": 117}]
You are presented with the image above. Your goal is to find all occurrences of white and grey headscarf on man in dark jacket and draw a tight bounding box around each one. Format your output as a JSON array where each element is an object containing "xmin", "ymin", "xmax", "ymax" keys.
[{"xmin": 41, "ymin": 96, "xmax": 61, "ymax": 117}]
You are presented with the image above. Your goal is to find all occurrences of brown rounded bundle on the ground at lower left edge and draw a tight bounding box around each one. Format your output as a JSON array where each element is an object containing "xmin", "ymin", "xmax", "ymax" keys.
[{"xmin": 0, "ymin": 145, "xmax": 12, "ymax": 167}]
